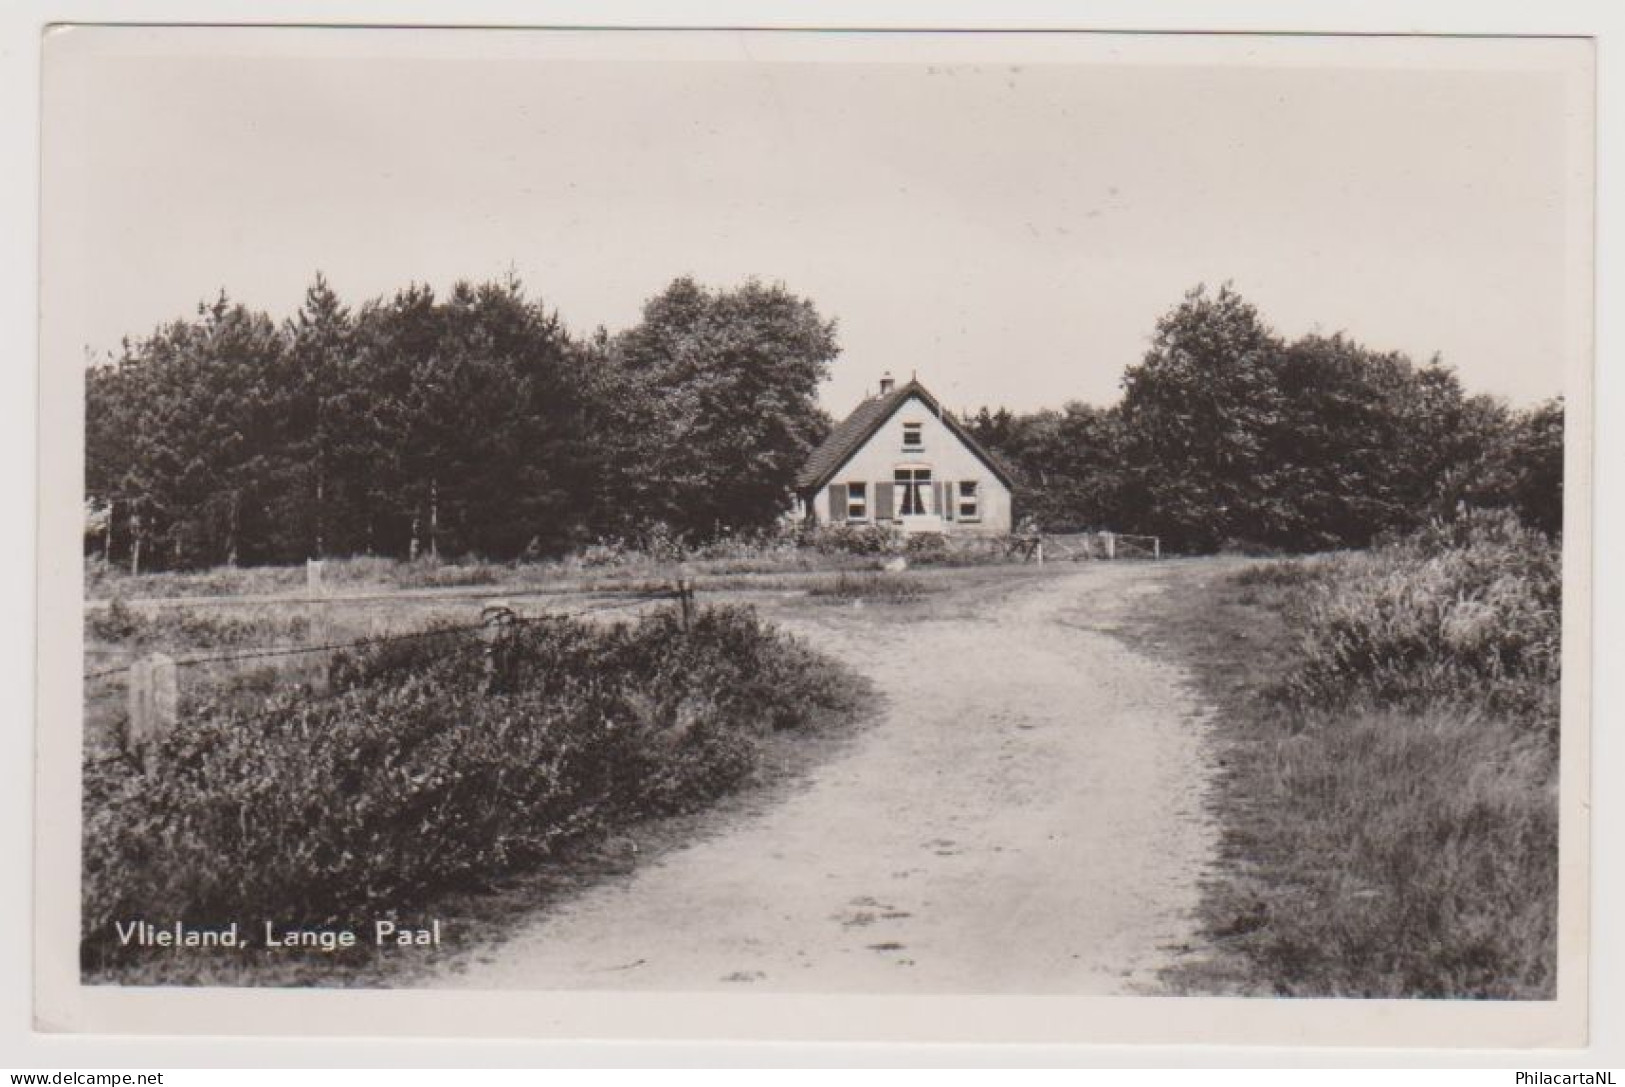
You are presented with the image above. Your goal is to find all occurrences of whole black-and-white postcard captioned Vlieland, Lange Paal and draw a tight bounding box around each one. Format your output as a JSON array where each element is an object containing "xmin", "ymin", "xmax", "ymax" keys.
[{"xmin": 34, "ymin": 24, "xmax": 1594, "ymax": 1045}]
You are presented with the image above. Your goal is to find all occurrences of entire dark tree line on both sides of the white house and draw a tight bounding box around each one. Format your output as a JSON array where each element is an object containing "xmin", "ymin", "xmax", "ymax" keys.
[{"xmin": 86, "ymin": 276, "xmax": 1563, "ymax": 569}]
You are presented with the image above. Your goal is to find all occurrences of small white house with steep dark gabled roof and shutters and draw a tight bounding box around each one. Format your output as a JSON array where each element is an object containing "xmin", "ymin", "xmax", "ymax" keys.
[{"xmin": 796, "ymin": 374, "xmax": 1011, "ymax": 536}]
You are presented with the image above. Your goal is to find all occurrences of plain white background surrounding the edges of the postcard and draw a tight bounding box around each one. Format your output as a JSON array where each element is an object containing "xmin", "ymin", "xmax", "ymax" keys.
[{"xmin": 0, "ymin": 0, "xmax": 1625, "ymax": 1065}]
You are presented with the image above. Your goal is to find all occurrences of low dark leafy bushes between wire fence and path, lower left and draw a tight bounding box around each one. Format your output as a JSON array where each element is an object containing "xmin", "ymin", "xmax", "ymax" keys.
[{"xmin": 81, "ymin": 608, "xmax": 861, "ymax": 970}]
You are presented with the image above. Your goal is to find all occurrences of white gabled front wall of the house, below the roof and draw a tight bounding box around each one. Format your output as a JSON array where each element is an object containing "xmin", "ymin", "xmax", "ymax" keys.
[{"xmin": 813, "ymin": 396, "xmax": 1011, "ymax": 535}]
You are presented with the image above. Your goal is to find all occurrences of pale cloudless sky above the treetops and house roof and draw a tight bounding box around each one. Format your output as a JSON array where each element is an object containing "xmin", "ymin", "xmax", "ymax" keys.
[{"xmin": 42, "ymin": 28, "xmax": 1589, "ymax": 414}]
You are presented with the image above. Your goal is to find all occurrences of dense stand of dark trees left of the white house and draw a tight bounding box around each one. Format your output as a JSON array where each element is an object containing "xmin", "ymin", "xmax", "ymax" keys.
[{"xmin": 86, "ymin": 278, "xmax": 835, "ymax": 569}]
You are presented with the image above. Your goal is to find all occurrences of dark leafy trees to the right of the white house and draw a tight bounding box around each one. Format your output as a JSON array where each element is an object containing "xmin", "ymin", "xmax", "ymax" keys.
[{"xmin": 967, "ymin": 286, "xmax": 1563, "ymax": 551}]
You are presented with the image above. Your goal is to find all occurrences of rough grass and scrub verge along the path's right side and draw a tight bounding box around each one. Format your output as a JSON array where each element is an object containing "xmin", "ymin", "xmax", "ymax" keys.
[{"xmin": 1138, "ymin": 513, "xmax": 1557, "ymax": 999}]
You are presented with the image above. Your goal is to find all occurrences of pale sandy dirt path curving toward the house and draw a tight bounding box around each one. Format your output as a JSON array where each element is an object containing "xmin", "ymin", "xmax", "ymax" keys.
[{"xmin": 432, "ymin": 564, "xmax": 1216, "ymax": 993}]
